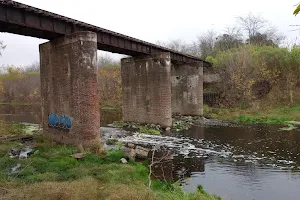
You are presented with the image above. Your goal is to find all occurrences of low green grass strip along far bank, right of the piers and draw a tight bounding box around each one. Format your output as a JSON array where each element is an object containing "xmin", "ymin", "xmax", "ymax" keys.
[{"xmin": 204, "ymin": 105, "xmax": 300, "ymax": 124}]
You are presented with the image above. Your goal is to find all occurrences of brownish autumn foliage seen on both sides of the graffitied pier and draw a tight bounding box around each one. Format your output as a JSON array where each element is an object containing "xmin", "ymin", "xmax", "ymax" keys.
[{"xmin": 0, "ymin": 65, "xmax": 122, "ymax": 106}]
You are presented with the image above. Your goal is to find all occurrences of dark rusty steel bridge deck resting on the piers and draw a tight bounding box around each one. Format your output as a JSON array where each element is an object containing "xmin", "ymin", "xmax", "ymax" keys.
[{"xmin": 0, "ymin": 0, "xmax": 210, "ymax": 67}]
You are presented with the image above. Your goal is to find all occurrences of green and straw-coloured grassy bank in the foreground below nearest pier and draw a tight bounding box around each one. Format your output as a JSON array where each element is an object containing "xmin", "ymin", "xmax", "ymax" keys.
[{"xmin": 0, "ymin": 124, "xmax": 219, "ymax": 200}]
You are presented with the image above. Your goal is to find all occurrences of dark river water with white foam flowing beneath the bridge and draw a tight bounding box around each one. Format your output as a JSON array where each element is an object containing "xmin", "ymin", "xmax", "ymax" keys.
[{"xmin": 0, "ymin": 105, "xmax": 300, "ymax": 200}]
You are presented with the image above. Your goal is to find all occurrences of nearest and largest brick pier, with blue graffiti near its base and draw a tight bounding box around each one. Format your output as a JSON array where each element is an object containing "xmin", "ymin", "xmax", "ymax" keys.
[{"xmin": 40, "ymin": 32, "xmax": 100, "ymax": 145}]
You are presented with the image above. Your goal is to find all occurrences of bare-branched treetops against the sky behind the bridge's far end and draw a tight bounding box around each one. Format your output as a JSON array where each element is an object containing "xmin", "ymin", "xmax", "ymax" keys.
[{"xmin": 157, "ymin": 13, "xmax": 285, "ymax": 59}]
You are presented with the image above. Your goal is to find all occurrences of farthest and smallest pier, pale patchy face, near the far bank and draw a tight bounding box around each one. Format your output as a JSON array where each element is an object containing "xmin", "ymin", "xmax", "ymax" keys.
[{"xmin": 172, "ymin": 63, "xmax": 203, "ymax": 115}]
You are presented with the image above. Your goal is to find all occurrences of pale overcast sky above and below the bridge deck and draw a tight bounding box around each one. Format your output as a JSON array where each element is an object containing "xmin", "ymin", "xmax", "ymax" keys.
[{"xmin": 0, "ymin": 0, "xmax": 300, "ymax": 65}]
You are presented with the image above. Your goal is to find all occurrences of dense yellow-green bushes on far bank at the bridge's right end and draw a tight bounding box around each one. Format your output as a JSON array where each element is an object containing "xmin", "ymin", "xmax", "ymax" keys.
[{"xmin": 207, "ymin": 45, "xmax": 300, "ymax": 107}]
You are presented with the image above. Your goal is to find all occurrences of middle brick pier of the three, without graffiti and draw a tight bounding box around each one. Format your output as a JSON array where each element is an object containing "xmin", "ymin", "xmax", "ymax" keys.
[{"xmin": 121, "ymin": 53, "xmax": 172, "ymax": 127}]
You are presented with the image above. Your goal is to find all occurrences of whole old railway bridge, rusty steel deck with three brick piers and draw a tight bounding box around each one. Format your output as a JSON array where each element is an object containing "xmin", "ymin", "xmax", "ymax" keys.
[{"xmin": 0, "ymin": 0, "xmax": 210, "ymax": 144}]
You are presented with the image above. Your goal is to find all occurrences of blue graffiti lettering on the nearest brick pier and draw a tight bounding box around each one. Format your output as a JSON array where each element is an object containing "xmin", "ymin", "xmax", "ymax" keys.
[{"xmin": 48, "ymin": 113, "xmax": 72, "ymax": 131}]
